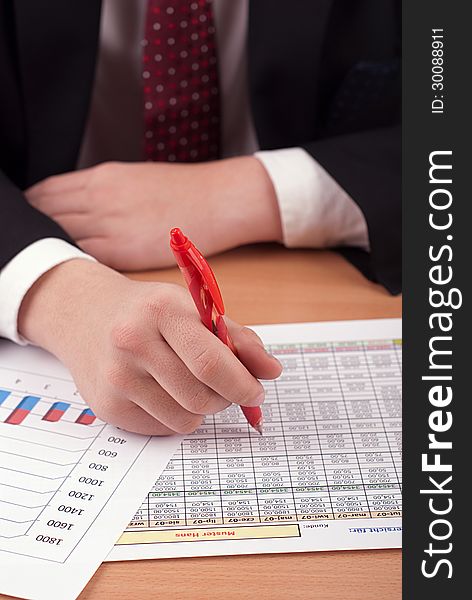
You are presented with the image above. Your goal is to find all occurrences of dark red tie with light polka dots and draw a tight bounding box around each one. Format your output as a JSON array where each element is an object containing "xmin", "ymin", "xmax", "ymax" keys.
[{"xmin": 143, "ymin": 0, "xmax": 220, "ymax": 162}]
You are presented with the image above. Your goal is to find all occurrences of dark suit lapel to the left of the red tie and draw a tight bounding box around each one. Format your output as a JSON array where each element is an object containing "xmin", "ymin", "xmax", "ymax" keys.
[{"xmin": 14, "ymin": 0, "xmax": 101, "ymax": 184}]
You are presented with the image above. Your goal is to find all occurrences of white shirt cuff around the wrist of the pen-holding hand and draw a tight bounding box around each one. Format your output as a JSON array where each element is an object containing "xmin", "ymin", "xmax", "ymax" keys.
[{"xmin": 0, "ymin": 238, "xmax": 95, "ymax": 345}]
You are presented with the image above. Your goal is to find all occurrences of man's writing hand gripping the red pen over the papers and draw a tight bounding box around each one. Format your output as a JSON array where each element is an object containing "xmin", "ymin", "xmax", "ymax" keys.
[{"xmin": 19, "ymin": 259, "xmax": 282, "ymax": 435}]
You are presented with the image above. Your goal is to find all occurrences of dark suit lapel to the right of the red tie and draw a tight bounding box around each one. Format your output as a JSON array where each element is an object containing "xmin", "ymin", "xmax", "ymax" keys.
[{"xmin": 248, "ymin": 0, "xmax": 332, "ymax": 149}]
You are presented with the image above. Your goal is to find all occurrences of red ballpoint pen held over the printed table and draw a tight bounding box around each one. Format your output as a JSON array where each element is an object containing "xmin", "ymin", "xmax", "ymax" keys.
[{"xmin": 170, "ymin": 227, "xmax": 263, "ymax": 434}]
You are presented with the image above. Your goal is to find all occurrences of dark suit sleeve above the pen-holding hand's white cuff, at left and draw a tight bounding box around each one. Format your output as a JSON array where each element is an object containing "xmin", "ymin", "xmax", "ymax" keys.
[{"xmin": 0, "ymin": 171, "xmax": 75, "ymax": 270}]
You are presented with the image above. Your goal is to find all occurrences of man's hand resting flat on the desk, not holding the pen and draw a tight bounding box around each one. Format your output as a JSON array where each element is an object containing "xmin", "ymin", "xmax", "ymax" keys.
[{"xmin": 26, "ymin": 157, "xmax": 282, "ymax": 270}]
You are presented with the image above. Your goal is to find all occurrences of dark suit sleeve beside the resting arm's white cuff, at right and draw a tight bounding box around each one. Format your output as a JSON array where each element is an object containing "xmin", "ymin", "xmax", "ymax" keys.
[{"xmin": 302, "ymin": 126, "xmax": 401, "ymax": 294}]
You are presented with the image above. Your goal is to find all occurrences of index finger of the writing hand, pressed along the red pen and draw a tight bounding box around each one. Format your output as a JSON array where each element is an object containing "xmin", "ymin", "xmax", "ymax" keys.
[{"xmin": 157, "ymin": 294, "xmax": 264, "ymax": 406}]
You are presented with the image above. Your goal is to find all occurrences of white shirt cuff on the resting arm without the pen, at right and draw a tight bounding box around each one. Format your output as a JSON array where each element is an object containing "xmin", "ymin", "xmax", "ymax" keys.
[{"xmin": 255, "ymin": 148, "xmax": 369, "ymax": 250}]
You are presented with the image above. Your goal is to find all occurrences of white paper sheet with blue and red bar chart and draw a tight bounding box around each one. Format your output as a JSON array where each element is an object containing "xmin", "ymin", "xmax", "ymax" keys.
[{"xmin": 0, "ymin": 342, "xmax": 181, "ymax": 600}]
